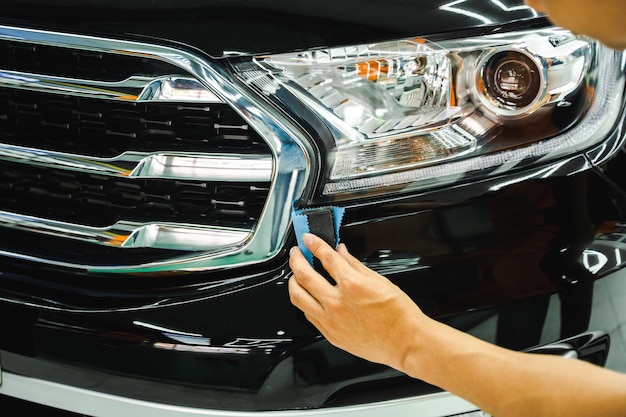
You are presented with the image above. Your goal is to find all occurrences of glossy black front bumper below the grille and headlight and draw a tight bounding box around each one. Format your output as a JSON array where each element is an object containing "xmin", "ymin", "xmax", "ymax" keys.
[{"xmin": 1, "ymin": 163, "xmax": 620, "ymax": 410}]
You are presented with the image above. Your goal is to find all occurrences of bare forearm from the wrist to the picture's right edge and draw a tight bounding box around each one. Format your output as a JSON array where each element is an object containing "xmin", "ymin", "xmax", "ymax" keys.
[{"xmin": 398, "ymin": 321, "xmax": 626, "ymax": 417}]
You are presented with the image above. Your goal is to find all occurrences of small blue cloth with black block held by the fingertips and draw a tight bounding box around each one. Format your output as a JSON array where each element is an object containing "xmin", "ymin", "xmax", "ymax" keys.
[{"xmin": 291, "ymin": 206, "xmax": 345, "ymax": 266}]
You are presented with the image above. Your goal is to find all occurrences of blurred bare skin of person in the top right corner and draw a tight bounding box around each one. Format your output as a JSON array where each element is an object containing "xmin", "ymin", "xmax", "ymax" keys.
[{"xmin": 526, "ymin": 0, "xmax": 626, "ymax": 50}]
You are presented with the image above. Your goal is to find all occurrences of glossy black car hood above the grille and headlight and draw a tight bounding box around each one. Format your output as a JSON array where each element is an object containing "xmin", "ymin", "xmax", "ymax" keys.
[{"xmin": 0, "ymin": 0, "xmax": 537, "ymax": 58}]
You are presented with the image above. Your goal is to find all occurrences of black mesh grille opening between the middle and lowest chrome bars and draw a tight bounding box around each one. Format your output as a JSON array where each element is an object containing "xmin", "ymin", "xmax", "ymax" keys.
[{"xmin": 0, "ymin": 161, "xmax": 269, "ymax": 227}]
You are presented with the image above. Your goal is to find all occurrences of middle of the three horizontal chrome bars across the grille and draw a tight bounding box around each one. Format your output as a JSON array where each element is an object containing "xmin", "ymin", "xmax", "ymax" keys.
[{"xmin": 0, "ymin": 143, "xmax": 274, "ymax": 182}]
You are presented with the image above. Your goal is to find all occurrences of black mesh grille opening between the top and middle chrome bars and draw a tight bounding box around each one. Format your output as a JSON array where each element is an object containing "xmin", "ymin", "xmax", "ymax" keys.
[{"xmin": 0, "ymin": 88, "xmax": 270, "ymax": 158}]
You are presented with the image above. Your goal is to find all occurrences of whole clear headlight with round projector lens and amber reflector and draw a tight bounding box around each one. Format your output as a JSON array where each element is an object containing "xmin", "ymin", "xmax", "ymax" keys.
[{"xmin": 251, "ymin": 28, "xmax": 623, "ymax": 198}]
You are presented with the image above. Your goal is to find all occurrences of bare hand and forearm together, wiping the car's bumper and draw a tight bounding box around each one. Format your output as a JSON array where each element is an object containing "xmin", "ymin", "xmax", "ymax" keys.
[{"xmin": 289, "ymin": 234, "xmax": 626, "ymax": 417}]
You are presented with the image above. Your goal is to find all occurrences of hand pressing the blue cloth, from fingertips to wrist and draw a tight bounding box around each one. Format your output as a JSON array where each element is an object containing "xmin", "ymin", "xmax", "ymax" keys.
[{"xmin": 289, "ymin": 234, "xmax": 427, "ymax": 369}]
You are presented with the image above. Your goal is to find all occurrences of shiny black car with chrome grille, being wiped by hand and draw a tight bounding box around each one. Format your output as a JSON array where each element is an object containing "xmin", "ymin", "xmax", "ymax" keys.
[{"xmin": 0, "ymin": 0, "xmax": 626, "ymax": 417}]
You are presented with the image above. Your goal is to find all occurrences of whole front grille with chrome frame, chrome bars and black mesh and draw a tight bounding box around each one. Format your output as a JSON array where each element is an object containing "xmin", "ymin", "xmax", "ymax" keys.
[{"xmin": 0, "ymin": 27, "xmax": 309, "ymax": 273}]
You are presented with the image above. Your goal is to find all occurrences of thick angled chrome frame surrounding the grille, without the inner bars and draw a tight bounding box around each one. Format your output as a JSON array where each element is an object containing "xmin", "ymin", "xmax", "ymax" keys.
[{"xmin": 0, "ymin": 26, "xmax": 315, "ymax": 273}]
